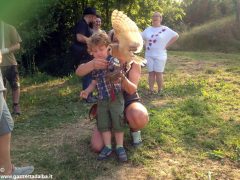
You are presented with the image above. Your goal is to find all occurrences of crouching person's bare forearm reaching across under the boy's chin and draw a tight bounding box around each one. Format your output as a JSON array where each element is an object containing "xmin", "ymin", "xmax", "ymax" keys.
[{"xmin": 75, "ymin": 58, "xmax": 108, "ymax": 76}]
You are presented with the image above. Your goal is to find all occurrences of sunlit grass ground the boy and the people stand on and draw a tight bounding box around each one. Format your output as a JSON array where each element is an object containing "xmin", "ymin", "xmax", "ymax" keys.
[{"xmin": 8, "ymin": 51, "xmax": 240, "ymax": 180}]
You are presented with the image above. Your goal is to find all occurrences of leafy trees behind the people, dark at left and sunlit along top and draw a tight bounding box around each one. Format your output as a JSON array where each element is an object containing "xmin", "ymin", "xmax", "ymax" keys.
[{"xmin": 0, "ymin": 0, "xmax": 184, "ymax": 75}]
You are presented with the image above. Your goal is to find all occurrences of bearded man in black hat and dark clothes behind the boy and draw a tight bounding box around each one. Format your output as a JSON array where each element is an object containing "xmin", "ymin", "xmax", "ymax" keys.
[{"xmin": 72, "ymin": 7, "xmax": 97, "ymax": 103}]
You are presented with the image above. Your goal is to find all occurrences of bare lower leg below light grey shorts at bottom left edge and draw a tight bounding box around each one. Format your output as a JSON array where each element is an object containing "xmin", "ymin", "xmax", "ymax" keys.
[{"xmin": 0, "ymin": 133, "xmax": 12, "ymax": 174}]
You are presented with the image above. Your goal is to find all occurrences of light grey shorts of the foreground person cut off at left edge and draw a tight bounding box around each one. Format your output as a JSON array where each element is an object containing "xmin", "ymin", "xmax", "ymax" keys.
[{"xmin": 0, "ymin": 91, "xmax": 14, "ymax": 136}]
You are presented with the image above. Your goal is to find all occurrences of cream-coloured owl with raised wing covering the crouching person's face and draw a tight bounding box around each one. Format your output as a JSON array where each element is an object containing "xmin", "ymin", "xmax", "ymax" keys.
[{"xmin": 111, "ymin": 10, "xmax": 143, "ymax": 64}]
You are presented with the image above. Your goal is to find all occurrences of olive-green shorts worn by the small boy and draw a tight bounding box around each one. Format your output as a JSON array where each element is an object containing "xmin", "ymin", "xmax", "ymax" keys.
[{"xmin": 97, "ymin": 93, "xmax": 125, "ymax": 132}]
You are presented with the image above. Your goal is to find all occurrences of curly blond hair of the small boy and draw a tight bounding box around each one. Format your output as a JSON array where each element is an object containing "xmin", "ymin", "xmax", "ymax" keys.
[{"xmin": 87, "ymin": 32, "xmax": 110, "ymax": 52}]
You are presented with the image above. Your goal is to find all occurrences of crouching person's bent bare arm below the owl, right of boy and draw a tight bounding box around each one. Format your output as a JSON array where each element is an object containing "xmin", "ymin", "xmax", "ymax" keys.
[{"xmin": 122, "ymin": 63, "xmax": 141, "ymax": 94}]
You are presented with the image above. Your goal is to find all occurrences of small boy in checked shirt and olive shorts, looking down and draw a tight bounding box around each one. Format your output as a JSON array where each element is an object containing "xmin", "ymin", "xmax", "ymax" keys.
[{"xmin": 80, "ymin": 32, "xmax": 127, "ymax": 162}]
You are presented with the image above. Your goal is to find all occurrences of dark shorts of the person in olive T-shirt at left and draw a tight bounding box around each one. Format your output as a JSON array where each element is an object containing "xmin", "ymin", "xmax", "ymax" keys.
[{"xmin": 1, "ymin": 65, "xmax": 20, "ymax": 90}]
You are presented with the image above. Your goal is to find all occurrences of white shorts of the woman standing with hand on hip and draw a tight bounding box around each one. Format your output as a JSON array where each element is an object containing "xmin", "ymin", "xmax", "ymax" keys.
[{"xmin": 145, "ymin": 56, "xmax": 167, "ymax": 72}]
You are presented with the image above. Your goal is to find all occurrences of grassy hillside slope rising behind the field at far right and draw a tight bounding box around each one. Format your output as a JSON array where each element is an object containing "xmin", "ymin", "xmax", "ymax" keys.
[{"xmin": 172, "ymin": 16, "xmax": 240, "ymax": 52}]
